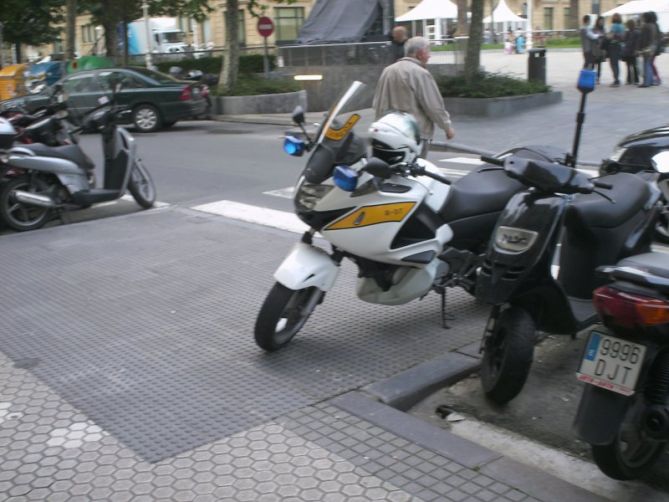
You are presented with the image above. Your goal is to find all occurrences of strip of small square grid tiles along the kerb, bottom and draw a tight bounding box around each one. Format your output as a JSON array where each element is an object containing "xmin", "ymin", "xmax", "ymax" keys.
[{"xmin": 277, "ymin": 403, "xmax": 535, "ymax": 502}]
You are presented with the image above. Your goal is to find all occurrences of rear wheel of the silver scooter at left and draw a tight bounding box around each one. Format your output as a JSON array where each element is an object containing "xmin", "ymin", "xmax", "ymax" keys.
[{"xmin": 0, "ymin": 176, "xmax": 51, "ymax": 232}]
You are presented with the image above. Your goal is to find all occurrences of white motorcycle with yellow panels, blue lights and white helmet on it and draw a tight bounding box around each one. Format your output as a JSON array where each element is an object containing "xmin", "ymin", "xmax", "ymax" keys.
[{"xmin": 255, "ymin": 82, "xmax": 528, "ymax": 351}]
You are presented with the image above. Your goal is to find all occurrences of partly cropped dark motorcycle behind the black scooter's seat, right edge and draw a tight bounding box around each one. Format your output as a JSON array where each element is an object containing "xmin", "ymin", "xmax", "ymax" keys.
[{"xmin": 599, "ymin": 125, "xmax": 669, "ymax": 244}]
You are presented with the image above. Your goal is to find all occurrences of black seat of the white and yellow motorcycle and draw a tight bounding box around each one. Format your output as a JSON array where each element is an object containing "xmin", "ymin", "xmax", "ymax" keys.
[{"xmin": 439, "ymin": 170, "xmax": 523, "ymax": 221}]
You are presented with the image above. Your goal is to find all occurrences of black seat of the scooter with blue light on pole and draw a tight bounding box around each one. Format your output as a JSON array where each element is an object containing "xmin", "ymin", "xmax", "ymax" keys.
[{"xmin": 567, "ymin": 173, "xmax": 650, "ymax": 228}]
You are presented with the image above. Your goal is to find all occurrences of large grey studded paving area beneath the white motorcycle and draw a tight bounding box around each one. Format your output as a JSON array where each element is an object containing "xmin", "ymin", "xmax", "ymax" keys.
[{"xmin": 0, "ymin": 208, "xmax": 485, "ymax": 461}]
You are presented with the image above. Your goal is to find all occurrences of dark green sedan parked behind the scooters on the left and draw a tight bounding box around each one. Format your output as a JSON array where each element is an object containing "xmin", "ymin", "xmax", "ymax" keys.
[{"xmin": 0, "ymin": 68, "xmax": 208, "ymax": 132}]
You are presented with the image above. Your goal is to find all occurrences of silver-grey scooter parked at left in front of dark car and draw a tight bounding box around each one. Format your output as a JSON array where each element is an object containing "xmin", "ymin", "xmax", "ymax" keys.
[{"xmin": 0, "ymin": 82, "xmax": 156, "ymax": 231}]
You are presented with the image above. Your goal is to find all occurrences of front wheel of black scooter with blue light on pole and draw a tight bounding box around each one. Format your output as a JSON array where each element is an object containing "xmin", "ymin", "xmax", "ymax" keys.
[{"xmin": 481, "ymin": 307, "xmax": 536, "ymax": 405}]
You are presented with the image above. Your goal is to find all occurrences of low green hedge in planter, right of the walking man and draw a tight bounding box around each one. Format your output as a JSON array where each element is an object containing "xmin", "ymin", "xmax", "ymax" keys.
[{"xmin": 437, "ymin": 73, "xmax": 550, "ymax": 98}]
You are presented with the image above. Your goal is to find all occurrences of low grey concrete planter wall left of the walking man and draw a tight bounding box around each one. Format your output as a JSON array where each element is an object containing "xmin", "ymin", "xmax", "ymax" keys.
[{"xmin": 213, "ymin": 90, "xmax": 308, "ymax": 115}]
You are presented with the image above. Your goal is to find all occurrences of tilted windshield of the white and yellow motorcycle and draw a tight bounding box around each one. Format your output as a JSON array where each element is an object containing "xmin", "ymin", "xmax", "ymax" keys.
[{"xmin": 303, "ymin": 81, "xmax": 365, "ymax": 183}]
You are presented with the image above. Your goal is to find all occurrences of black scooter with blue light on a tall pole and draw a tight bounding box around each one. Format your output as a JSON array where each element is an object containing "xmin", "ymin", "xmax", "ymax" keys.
[{"xmin": 476, "ymin": 70, "xmax": 659, "ymax": 404}]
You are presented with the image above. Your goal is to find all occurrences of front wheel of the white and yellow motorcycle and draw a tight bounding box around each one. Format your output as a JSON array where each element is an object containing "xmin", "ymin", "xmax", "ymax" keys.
[{"xmin": 255, "ymin": 282, "xmax": 325, "ymax": 352}]
